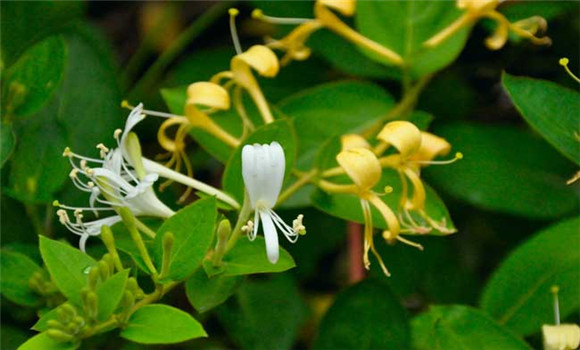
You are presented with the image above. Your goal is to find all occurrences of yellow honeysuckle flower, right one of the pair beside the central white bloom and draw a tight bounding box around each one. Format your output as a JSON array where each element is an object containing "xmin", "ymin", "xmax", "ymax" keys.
[{"xmin": 375, "ymin": 121, "xmax": 463, "ymax": 233}]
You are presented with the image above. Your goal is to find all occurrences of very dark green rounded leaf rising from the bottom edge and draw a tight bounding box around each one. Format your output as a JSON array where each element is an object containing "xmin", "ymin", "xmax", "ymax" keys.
[{"xmin": 312, "ymin": 280, "xmax": 411, "ymax": 349}]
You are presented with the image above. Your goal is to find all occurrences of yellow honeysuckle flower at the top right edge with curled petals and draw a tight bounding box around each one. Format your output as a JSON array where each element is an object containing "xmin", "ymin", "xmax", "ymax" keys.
[{"xmin": 424, "ymin": 0, "xmax": 552, "ymax": 50}]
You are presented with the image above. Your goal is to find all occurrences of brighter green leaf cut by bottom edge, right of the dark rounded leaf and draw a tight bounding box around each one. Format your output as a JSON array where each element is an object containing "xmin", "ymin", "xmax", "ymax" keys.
[{"xmin": 412, "ymin": 305, "xmax": 531, "ymax": 350}]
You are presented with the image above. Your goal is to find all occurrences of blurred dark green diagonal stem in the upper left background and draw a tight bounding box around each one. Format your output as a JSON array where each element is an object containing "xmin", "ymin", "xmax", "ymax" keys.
[{"xmin": 129, "ymin": 1, "xmax": 235, "ymax": 96}]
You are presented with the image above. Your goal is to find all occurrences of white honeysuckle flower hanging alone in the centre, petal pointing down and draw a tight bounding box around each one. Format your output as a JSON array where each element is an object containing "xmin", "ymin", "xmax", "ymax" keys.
[{"xmin": 242, "ymin": 141, "xmax": 305, "ymax": 264}]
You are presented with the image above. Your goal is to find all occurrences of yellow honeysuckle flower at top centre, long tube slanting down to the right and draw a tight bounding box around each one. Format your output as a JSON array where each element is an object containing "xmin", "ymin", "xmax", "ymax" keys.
[{"xmin": 252, "ymin": 0, "xmax": 403, "ymax": 66}]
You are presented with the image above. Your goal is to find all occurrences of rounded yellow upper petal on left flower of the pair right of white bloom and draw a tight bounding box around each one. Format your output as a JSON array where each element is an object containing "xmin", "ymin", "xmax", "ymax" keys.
[{"xmin": 336, "ymin": 148, "xmax": 381, "ymax": 192}]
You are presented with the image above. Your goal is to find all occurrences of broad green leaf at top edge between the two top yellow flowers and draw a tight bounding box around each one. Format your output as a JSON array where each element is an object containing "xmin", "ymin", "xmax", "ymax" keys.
[{"xmin": 355, "ymin": 0, "xmax": 469, "ymax": 77}]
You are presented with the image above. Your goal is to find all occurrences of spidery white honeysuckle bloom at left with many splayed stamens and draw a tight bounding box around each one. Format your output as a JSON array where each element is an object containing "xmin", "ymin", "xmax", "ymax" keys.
[{"xmin": 54, "ymin": 104, "xmax": 174, "ymax": 251}]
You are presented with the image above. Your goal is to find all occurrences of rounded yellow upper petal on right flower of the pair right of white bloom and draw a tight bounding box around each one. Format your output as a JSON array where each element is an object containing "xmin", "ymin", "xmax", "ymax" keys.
[{"xmin": 377, "ymin": 121, "xmax": 421, "ymax": 158}]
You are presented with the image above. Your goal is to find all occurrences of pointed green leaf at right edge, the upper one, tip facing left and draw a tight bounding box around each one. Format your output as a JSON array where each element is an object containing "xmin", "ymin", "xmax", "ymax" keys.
[{"xmin": 502, "ymin": 74, "xmax": 580, "ymax": 165}]
